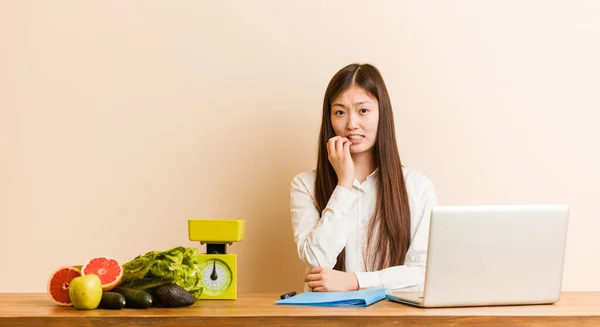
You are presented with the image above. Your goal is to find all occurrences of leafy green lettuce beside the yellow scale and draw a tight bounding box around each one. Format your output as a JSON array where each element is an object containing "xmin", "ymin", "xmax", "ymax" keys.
[{"xmin": 119, "ymin": 246, "xmax": 202, "ymax": 300}]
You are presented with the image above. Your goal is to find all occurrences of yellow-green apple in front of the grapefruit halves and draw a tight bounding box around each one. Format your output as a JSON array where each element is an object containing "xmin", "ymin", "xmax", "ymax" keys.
[{"xmin": 69, "ymin": 274, "xmax": 102, "ymax": 310}]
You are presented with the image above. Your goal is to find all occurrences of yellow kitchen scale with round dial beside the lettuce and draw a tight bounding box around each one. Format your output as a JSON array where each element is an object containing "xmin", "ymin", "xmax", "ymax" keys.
[{"xmin": 188, "ymin": 219, "xmax": 246, "ymax": 300}]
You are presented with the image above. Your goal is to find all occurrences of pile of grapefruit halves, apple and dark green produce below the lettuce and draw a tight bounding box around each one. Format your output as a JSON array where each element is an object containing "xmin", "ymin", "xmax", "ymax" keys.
[{"xmin": 47, "ymin": 257, "xmax": 196, "ymax": 310}]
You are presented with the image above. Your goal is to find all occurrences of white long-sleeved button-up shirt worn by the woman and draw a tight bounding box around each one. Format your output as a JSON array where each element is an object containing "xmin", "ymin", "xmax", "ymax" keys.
[{"xmin": 290, "ymin": 168, "xmax": 437, "ymax": 292}]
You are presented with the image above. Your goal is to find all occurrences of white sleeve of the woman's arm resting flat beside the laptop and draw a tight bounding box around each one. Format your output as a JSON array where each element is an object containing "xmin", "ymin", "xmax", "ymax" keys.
[{"xmin": 355, "ymin": 178, "xmax": 438, "ymax": 292}]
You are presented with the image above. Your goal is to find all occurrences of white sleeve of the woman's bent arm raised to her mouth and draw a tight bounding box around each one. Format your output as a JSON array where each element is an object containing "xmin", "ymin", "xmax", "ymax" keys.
[{"xmin": 290, "ymin": 176, "xmax": 356, "ymax": 268}]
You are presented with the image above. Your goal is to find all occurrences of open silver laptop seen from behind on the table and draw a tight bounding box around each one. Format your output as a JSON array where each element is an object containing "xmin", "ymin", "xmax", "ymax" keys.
[{"xmin": 386, "ymin": 205, "xmax": 569, "ymax": 308}]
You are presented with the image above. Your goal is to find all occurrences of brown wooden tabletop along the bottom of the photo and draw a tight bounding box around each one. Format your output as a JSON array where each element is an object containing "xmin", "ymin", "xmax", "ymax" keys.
[{"xmin": 0, "ymin": 292, "xmax": 600, "ymax": 327}]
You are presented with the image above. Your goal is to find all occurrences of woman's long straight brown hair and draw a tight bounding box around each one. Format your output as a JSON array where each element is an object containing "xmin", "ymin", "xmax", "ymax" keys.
[{"xmin": 315, "ymin": 64, "xmax": 410, "ymax": 271}]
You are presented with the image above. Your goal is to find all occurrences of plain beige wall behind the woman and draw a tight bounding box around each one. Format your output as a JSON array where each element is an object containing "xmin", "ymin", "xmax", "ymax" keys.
[{"xmin": 0, "ymin": 0, "xmax": 600, "ymax": 292}]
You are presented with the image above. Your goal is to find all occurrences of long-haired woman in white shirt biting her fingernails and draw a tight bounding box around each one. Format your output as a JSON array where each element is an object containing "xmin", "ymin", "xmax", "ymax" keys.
[{"xmin": 290, "ymin": 64, "xmax": 437, "ymax": 292}]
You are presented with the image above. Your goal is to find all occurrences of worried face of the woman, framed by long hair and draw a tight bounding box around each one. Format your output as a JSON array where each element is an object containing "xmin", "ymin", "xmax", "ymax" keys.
[{"xmin": 331, "ymin": 85, "xmax": 379, "ymax": 154}]
